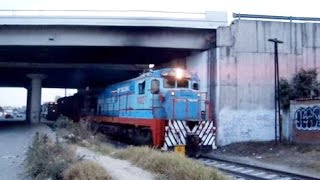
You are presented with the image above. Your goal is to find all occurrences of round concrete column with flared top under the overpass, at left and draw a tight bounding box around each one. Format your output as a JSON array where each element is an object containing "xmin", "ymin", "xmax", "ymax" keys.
[{"xmin": 27, "ymin": 74, "xmax": 45, "ymax": 124}]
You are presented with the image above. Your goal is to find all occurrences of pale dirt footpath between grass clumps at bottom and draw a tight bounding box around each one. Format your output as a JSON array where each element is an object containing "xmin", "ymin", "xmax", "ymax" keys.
[{"xmin": 77, "ymin": 147, "xmax": 155, "ymax": 180}]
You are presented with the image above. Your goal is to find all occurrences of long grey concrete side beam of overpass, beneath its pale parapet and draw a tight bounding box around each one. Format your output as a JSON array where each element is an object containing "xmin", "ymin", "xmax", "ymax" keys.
[{"xmin": 0, "ymin": 25, "xmax": 214, "ymax": 49}]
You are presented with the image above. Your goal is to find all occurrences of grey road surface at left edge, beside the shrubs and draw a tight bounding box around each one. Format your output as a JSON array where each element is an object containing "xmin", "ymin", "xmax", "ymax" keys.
[{"xmin": 0, "ymin": 123, "xmax": 54, "ymax": 180}]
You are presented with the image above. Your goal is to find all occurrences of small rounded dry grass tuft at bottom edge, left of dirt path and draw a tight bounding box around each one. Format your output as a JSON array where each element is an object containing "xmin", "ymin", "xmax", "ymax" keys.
[{"xmin": 64, "ymin": 161, "xmax": 112, "ymax": 180}]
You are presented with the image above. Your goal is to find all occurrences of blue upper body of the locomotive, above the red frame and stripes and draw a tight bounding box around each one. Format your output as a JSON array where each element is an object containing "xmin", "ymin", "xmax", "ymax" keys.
[{"xmin": 97, "ymin": 68, "xmax": 205, "ymax": 121}]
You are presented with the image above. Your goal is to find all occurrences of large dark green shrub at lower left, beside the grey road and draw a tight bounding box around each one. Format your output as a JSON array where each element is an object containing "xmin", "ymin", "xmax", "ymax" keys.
[{"xmin": 25, "ymin": 133, "xmax": 77, "ymax": 180}]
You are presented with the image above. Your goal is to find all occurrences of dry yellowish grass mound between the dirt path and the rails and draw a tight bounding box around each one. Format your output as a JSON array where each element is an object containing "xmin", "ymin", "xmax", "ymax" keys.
[{"xmin": 114, "ymin": 147, "xmax": 227, "ymax": 180}]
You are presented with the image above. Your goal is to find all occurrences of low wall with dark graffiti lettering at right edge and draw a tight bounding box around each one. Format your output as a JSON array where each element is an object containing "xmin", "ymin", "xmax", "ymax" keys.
[{"xmin": 290, "ymin": 100, "xmax": 320, "ymax": 144}]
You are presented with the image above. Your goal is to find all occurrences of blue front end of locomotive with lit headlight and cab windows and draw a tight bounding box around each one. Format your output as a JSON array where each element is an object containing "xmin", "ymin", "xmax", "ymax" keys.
[{"xmin": 155, "ymin": 69, "xmax": 206, "ymax": 121}]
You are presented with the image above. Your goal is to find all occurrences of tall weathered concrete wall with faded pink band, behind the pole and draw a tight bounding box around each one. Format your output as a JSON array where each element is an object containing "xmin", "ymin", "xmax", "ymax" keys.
[{"xmin": 215, "ymin": 20, "xmax": 320, "ymax": 146}]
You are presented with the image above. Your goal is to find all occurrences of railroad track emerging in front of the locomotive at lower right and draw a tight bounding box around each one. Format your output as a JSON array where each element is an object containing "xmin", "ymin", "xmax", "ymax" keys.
[{"xmin": 198, "ymin": 155, "xmax": 320, "ymax": 180}]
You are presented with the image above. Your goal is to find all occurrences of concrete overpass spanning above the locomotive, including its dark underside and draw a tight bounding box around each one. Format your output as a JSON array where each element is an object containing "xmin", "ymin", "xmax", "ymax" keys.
[{"xmin": 0, "ymin": 11, "xmax": 227, "ymax": 122}]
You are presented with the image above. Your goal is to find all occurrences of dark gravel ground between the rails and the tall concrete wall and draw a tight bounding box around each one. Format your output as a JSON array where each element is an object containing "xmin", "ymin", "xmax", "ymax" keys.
[{"xmin": 209, "ymin": 142, "xmax": 320, "ymax": 178}]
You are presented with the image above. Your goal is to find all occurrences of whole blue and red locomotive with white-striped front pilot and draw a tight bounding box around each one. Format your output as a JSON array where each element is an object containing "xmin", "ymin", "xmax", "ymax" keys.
[{"xmin": 79, "ymin": 68, "xmax": 215, "ymax": 152}]
